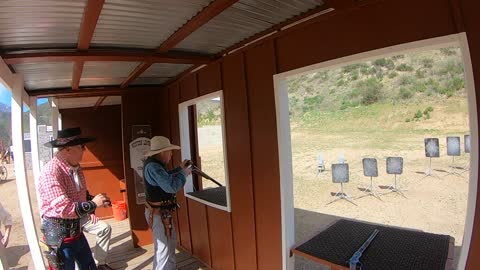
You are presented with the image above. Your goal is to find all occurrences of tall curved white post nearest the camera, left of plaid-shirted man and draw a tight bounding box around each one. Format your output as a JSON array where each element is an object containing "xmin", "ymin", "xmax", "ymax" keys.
[{"xmin": 12, "ymin": 74, "xmax": 45, "ymax": 269}]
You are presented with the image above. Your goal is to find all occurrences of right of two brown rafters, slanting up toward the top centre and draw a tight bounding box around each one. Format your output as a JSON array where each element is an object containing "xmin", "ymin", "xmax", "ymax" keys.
[{"xmin": 121, "ymin": 0, "xmax": 238, "ymax": 87}]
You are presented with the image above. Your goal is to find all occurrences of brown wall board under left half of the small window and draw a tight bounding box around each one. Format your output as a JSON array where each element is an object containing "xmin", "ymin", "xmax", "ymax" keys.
[{"xmin": 187, "ymin": 199, "xmax": 211, "ymax": 265}]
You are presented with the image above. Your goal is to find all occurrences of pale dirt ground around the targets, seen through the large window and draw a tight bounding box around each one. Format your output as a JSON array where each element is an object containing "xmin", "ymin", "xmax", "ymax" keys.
[{"xmin": 292, "ymin": 132, "xmax": 469, "ymax": 270}]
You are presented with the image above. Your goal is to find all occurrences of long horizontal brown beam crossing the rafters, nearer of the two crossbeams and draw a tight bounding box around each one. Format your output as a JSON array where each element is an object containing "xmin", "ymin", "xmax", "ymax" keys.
[{"xmin": 0, "ymin": 51, "xmax": 213, "ymax": 65}]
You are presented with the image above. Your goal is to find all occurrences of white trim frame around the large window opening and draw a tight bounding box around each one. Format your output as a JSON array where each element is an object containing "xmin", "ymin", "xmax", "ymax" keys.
[{"xmin": 273, "ymin": 33, "xmax": 479, "ymax": 270}]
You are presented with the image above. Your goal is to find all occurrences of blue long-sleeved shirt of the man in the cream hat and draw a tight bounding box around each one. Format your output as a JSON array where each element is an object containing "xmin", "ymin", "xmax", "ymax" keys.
[{"xmin": 143, "ymin": 157, "xmax": 187, "ymax": 193}]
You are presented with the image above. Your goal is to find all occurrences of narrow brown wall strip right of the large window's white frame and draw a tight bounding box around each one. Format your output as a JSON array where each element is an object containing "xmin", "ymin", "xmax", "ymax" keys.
[{"xmin": 459, "ymin": 0, "xmax": 480, "ymax": 270}]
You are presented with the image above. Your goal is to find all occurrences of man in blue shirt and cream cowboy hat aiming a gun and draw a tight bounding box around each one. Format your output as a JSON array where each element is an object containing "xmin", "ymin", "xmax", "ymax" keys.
[{"xmin": 143, "ymin": 136, "xmax": 191, "ymax": 270}]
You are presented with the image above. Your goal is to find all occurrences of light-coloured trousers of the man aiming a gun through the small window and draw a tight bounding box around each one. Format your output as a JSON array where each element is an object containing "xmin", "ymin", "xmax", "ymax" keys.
[{"xmin": 145, "ymin": 209, "xmax": 177, "ymax": 270}]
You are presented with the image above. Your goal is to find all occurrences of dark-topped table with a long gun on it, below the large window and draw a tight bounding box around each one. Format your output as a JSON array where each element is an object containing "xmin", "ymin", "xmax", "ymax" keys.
[{"xmin": 292, "ymin": 219, "xmax": 455, "ymax": 270}]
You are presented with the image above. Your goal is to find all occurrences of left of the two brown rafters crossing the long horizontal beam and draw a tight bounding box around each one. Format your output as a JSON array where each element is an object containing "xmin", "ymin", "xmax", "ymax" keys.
[{"xmin": 72, "ymin": 0, "xmax": 105, "ymax": 89}]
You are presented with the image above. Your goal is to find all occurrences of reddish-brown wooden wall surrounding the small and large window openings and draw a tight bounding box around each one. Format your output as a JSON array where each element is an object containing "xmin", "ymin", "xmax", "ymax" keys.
[{"xmin": 119, "ymin": 0, "xmax": 480, "ymax": 270}]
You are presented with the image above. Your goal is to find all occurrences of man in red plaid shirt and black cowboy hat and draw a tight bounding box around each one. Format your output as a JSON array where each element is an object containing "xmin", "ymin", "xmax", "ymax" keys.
[{"xmin": 39, "ymin": 128, "xmax": 109, "ymax": 269}]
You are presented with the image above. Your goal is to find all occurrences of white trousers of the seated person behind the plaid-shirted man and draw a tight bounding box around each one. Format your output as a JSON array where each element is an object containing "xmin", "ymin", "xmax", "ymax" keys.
[{"xmin": 83, "ymin": 220, "xmax": 112, "ymax": 265}]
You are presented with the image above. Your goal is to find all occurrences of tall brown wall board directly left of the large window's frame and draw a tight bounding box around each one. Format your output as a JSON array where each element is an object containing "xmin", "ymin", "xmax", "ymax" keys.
[{"xmin": 245, "ymin": 41, "xmax": 282, "ymax": 270}]
